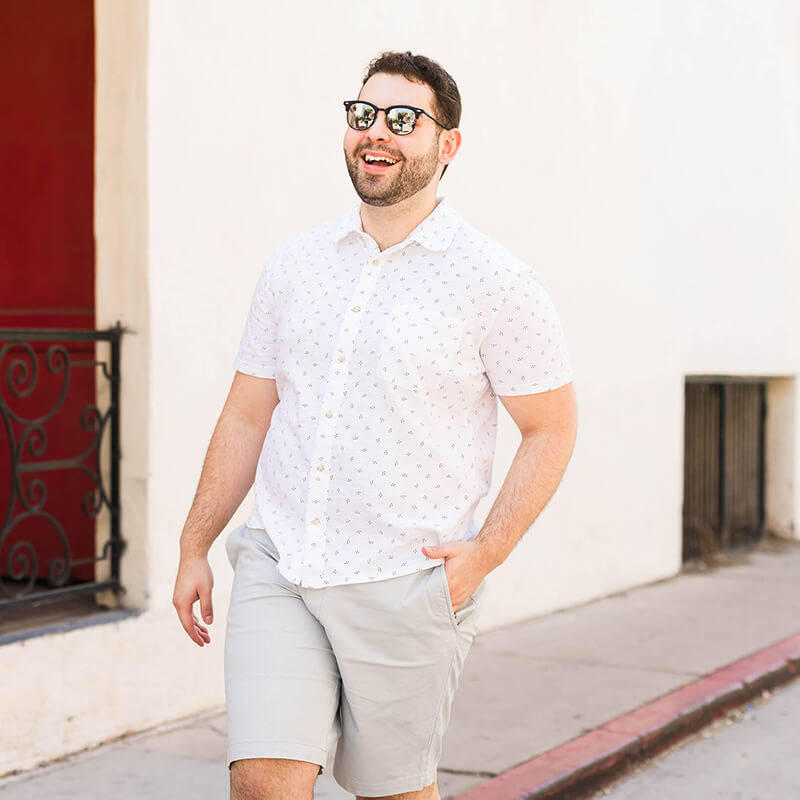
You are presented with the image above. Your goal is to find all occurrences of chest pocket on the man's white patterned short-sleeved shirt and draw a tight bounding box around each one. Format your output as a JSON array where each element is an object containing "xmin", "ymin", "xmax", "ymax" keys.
[{"xmin": 378, "ymin": 303, "xmax": 464, "ymax": 390}]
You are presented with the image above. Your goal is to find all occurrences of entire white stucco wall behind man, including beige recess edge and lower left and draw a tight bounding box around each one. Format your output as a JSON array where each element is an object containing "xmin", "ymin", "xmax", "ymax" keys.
[{"xmin": 0, "ymin": 0, "xmax": 800, "ymax": 774}]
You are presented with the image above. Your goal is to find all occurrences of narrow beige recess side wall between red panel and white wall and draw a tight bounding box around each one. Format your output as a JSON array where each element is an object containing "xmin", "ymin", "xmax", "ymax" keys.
[{"xmin": 95, "ymin": 0, "xmax": 151, "ymax": 609}]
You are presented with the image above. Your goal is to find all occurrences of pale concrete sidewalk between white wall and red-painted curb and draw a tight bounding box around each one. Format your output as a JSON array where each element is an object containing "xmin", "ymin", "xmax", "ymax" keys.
[{"xmin": 0, "ymin": 540, "xmax": 800, "ymax": 800}]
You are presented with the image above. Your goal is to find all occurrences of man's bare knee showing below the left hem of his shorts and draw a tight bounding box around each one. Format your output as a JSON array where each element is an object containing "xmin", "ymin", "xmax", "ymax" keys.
[{"xmin": 231, "ymin": 758, "xmax": 320, "ymax": 800}]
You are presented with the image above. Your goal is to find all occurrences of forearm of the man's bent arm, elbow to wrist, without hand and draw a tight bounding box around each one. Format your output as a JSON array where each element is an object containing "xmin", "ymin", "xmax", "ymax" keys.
[{"xmin": 475, "ymin": 431, "xmax": 575, "ymax": 570}]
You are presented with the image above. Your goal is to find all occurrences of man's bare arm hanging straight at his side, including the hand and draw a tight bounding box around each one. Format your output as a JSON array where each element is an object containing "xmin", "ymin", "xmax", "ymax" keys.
[{"xmin": 172, "ymin": 372, "xmax": 279, "ymax": 647}]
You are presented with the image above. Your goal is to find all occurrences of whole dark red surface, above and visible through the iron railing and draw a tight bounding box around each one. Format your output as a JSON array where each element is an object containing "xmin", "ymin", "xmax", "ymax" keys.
[{"xmin": 0, "ymin": 0, "xmax": 95, "ymax": 579}]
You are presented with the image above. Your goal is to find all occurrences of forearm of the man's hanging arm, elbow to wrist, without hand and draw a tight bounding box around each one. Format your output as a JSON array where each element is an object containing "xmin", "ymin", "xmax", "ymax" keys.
[{"xmin": 180, "ymin": 411, "xmax": 269, "ymax": 557}]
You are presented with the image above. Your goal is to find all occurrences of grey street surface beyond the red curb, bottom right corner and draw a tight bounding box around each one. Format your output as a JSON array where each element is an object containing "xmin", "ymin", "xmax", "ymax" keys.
[{"xmin": 595, "ymin": 678, "xmax": 800, "ymax": 800}]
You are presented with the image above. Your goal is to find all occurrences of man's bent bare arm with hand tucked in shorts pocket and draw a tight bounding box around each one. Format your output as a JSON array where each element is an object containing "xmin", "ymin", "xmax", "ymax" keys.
[{"xmin": 422, "ymin": 382, "xmax": 578, "ymax": 609}]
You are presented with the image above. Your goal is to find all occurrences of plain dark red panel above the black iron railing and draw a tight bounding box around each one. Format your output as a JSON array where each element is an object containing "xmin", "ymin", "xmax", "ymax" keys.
[{"xmin": 0, "ymin": 0, "xmax": 95, "ymax": 328}]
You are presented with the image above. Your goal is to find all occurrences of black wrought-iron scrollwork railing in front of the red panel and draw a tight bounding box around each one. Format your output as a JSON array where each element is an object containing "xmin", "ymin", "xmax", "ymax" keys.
[{"xmin": 0, "ymin": 323, "xmax": 124, "ymax": 610}]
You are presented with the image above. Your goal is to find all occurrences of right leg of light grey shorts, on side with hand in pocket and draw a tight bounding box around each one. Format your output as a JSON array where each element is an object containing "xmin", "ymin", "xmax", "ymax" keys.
[{"xmin": 322, "ymin": 563, "xmax": 484, "ymax": 796}]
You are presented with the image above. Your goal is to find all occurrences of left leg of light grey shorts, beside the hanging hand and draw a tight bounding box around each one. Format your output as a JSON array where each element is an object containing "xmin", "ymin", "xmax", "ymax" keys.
[{"xmin": 225, "ymin": 528, "xmax": 340, "ymax": 767}]
